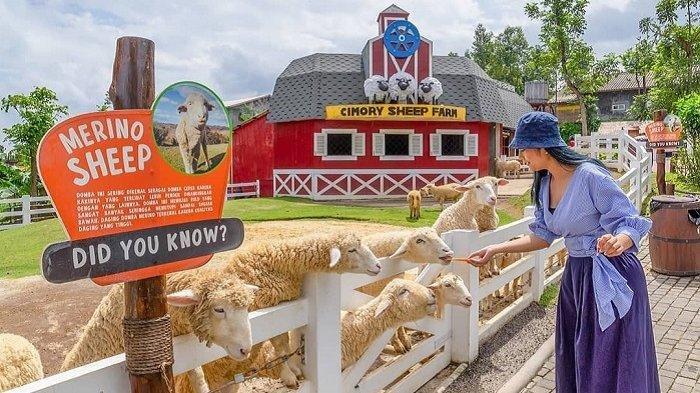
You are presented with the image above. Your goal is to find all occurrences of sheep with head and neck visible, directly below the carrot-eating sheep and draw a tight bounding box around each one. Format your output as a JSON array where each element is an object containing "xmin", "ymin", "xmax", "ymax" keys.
[{"xmin": 340, "ymin": 279, "xmax": 437, "ymax": 370}]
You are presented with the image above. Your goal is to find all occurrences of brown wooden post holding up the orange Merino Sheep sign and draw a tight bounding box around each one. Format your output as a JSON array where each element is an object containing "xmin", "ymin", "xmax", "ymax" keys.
[{"xmin": 109, "ymin": 37, "xmax": 174, "ymax": 393}]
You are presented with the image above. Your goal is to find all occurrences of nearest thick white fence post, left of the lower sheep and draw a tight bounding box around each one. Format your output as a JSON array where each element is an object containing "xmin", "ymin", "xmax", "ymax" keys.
[{"xmin": 304, "ymin": 273, "xmax": 343, "ymax": 393}]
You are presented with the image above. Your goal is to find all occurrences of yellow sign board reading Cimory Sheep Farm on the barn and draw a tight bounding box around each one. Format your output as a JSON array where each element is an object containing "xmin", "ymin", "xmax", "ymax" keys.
[{"xmin": 326, "ymin": 104, "xmax": 467, "ymax": 121}]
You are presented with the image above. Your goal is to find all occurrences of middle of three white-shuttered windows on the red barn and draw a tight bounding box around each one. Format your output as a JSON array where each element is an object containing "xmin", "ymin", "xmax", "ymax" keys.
[{"xmin": 372, "ymin": 129, "xmax": 423, "ymax": 161}]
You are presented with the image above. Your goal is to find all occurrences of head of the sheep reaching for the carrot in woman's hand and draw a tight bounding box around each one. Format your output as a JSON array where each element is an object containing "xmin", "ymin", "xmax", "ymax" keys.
[{"xmin": 380, "ymin": 227, "xmax": 454, "ymax": 265}]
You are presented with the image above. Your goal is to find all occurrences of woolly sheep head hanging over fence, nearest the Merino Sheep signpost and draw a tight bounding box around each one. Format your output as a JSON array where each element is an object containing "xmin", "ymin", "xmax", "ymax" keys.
[{"xmin": 167, "ymin": 270, "xmax": 258, "ymax": 360}]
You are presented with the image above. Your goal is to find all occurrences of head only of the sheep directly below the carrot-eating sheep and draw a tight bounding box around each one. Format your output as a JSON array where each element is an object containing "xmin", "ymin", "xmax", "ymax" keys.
[{"xmin": 374, "ymin": 279, "xmax": 437, "ymax": 320}]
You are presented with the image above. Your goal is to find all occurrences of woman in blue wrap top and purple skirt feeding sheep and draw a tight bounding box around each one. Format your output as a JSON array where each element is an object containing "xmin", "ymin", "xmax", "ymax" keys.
[{"xmin": 468, "ymin": 112, "xmax": 660, "ymax": 393}]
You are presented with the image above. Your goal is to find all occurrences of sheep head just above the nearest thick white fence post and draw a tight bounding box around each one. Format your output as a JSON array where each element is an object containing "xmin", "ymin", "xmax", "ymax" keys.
[{"xmin": 329, "ymin": 235, "xmax": 382, "ymax": 276}]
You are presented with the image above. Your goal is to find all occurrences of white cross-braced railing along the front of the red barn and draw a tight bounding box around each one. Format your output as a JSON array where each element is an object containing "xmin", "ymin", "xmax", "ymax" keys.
[{"xmin": 273, "ymin": 169, "xmax": 478, "ymax": 200}]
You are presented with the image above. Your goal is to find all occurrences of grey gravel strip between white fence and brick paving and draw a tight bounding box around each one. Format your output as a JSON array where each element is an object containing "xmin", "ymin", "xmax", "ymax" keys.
[{"xmin": 438, "ymin": 303, "xmax": 556, "ymax": 393}]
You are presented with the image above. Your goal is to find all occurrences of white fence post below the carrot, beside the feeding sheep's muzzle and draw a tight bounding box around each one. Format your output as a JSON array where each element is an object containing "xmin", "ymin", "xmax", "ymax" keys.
[{"xmin": 442, "ymin": 230, "xmax": 481, "ymax": 363}]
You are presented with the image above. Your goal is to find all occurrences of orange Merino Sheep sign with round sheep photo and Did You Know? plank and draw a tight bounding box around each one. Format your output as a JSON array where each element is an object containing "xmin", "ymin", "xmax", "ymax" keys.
[{"xmin": 37, "ymin": 82, "xmax": 243, "ymax": 285}]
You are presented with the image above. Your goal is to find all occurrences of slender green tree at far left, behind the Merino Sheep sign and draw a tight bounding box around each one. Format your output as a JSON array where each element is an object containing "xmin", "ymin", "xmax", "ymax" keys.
[{"xmin": 0, "ymin": 87, "xmax": 68, "ymax": 196}]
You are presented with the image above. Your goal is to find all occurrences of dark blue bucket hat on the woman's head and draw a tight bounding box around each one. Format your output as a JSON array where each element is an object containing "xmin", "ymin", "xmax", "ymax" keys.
[{"xmin": 509, "ymin": 112, "xmax": 566, "ymax": 149}]
